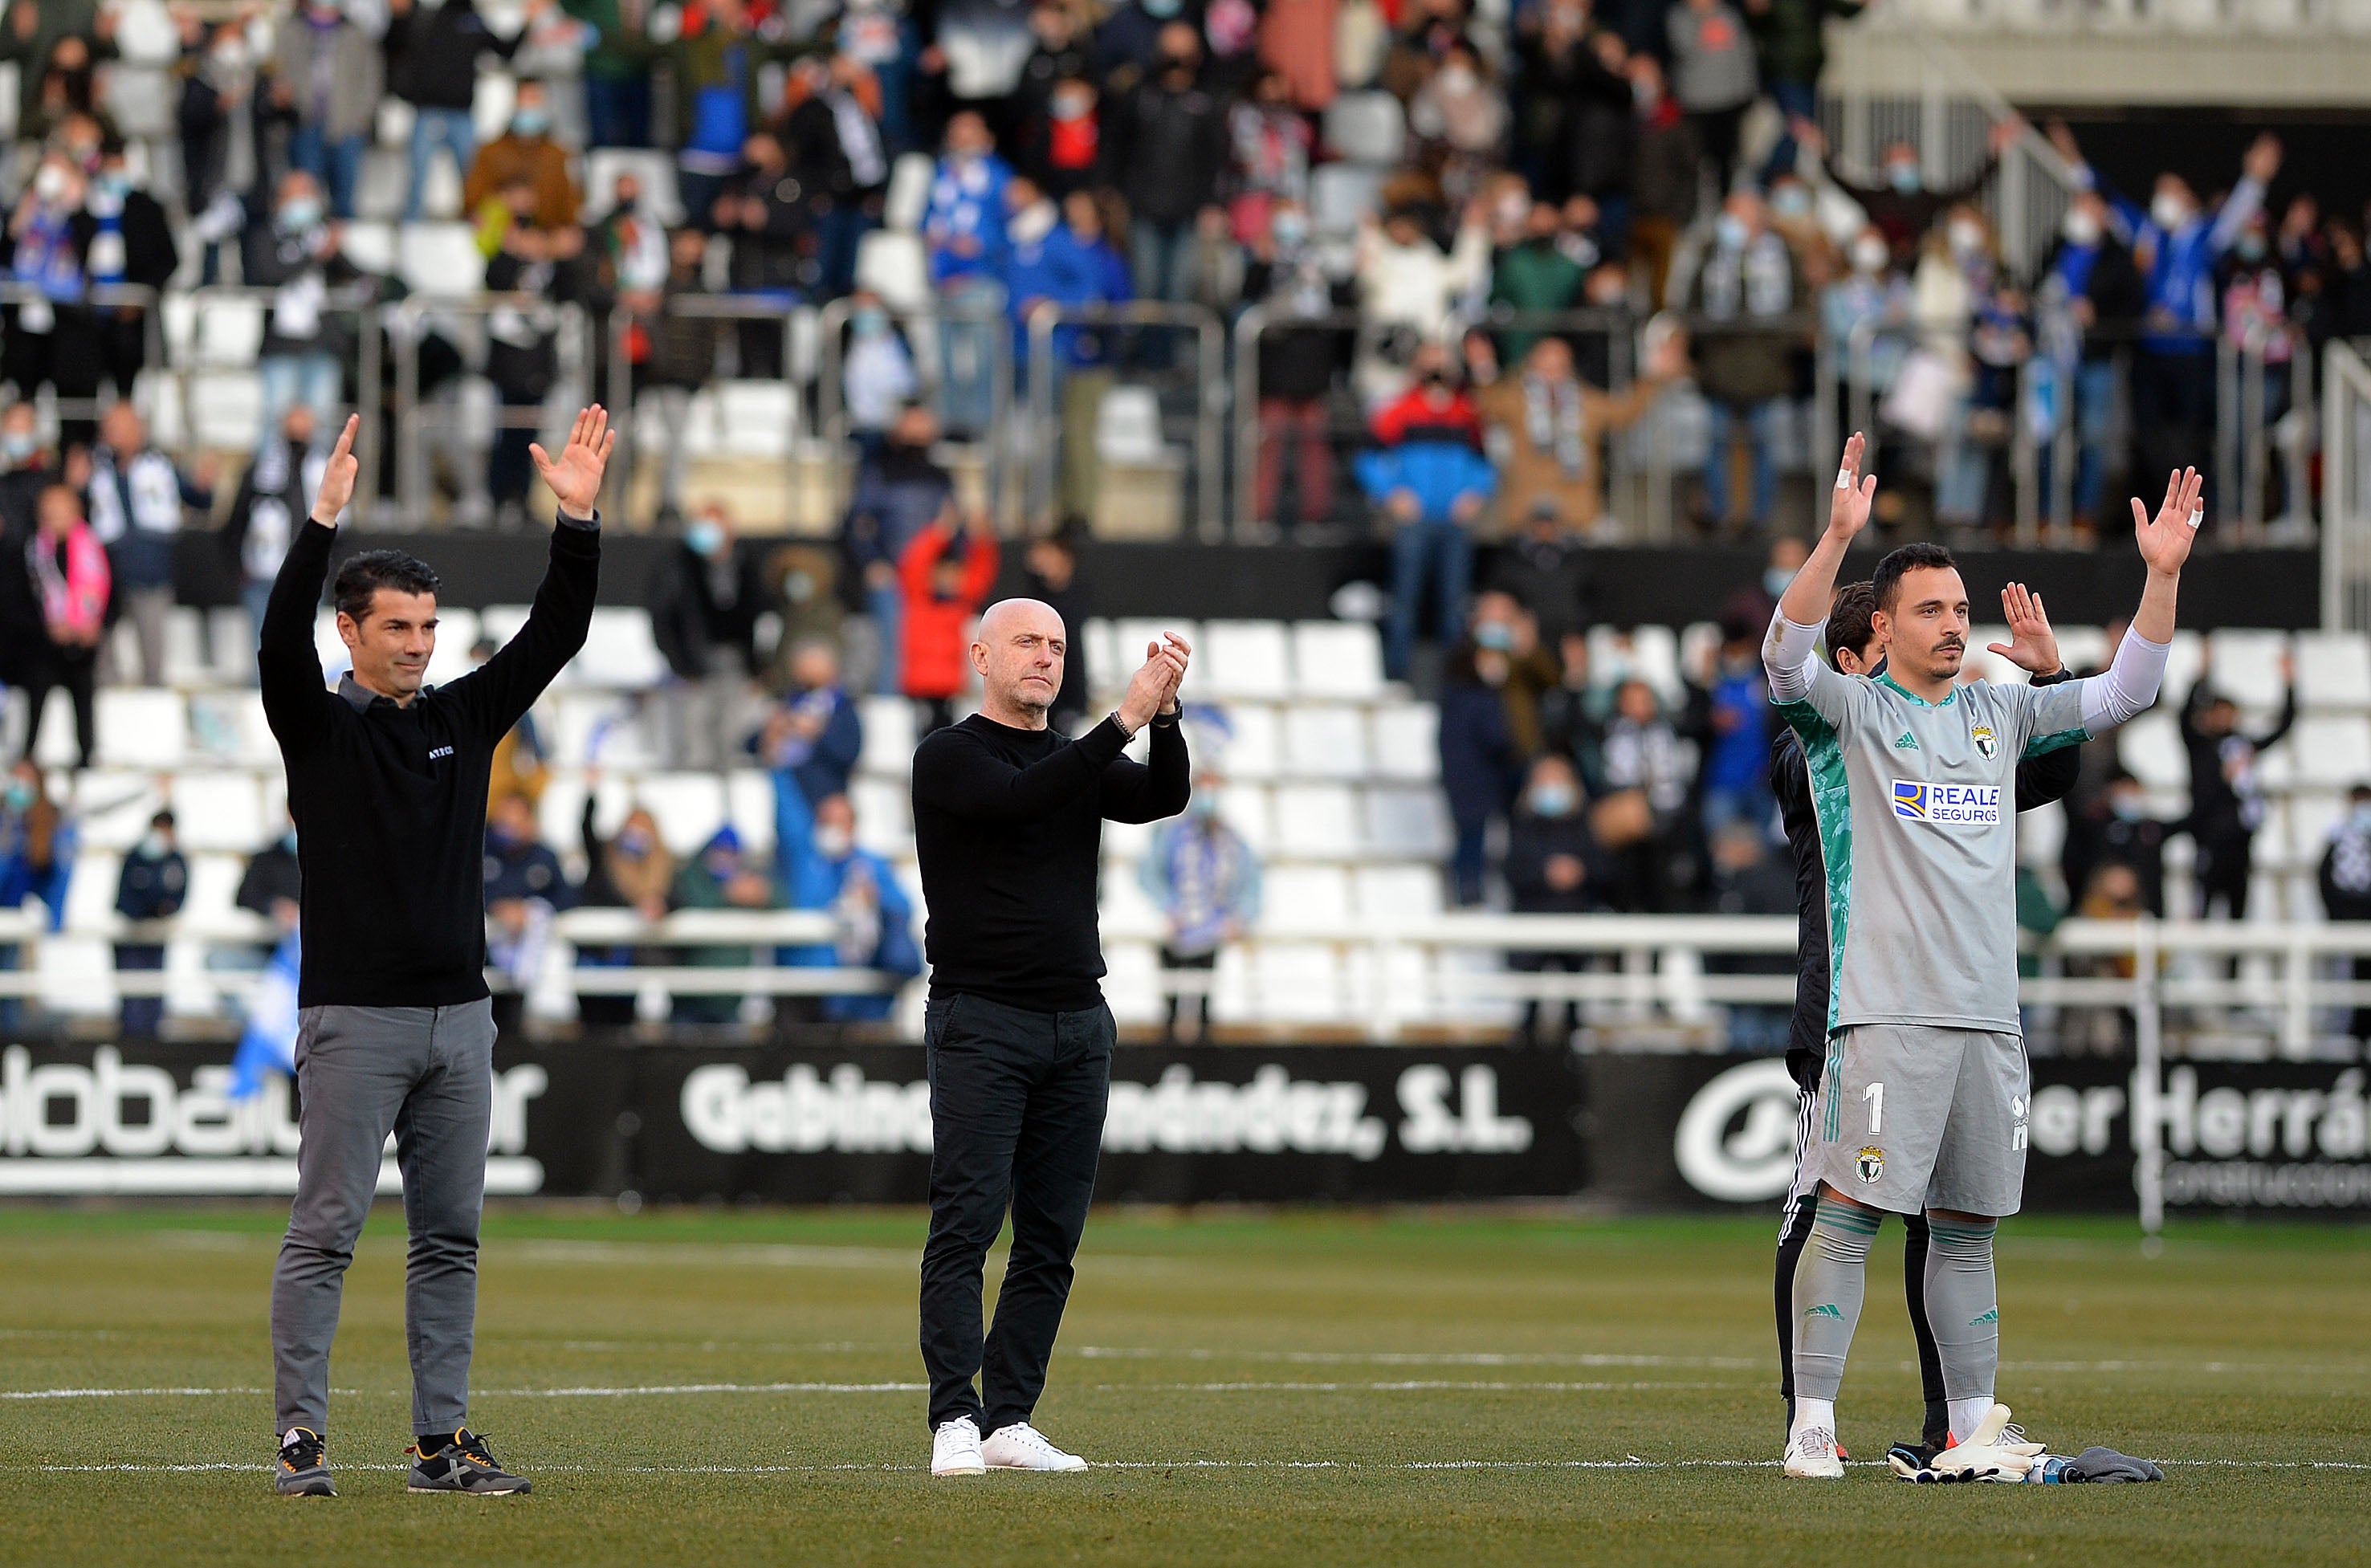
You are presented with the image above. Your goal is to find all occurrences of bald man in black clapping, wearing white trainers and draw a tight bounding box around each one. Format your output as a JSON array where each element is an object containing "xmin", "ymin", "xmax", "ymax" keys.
[{"xmin": 913, "ymin": 598, "xmax": 1190, "ymax": 1476}]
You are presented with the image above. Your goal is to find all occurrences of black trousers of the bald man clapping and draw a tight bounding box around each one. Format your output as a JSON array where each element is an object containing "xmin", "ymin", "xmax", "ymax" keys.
[{"xmin": 923, "ymin": 994, "xmax": 1117, "ymax": 1437}]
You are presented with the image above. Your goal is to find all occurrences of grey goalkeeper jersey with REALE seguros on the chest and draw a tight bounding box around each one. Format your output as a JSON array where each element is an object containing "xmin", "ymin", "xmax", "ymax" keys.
[{"xmin": 1778, "ymin": 662, "xmax": 2092, "ymax": 1034}]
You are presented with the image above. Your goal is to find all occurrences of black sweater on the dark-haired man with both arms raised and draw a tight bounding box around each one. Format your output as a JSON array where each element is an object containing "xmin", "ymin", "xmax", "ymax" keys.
[{"xmin": 256, "ymin": 519, "xmax": 600, "ymax": 1008}]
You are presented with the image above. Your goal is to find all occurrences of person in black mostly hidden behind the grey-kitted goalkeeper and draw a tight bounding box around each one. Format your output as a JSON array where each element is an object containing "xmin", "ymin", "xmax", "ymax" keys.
[{"xmin": 1771, "ymin": 584, "xmax": 2082, "ymax": 1466}]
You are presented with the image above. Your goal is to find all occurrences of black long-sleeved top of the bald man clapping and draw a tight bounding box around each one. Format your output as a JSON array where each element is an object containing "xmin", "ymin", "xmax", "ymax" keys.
[{"xmin": 913, "ymin": 714, "xmax": 1190, "ymax": 1013}]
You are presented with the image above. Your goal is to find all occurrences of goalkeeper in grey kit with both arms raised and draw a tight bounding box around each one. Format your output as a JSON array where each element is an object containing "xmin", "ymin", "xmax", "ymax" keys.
[{"xmin": 1762, "ymin": 434, "xmax": 2202, "ymax": 1480}]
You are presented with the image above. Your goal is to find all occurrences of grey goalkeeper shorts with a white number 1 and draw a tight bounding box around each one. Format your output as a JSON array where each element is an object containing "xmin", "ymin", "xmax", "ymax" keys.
[{"xmin": 1804, "ymin": 1024, "xmax": 2032, "ymax": 1217}]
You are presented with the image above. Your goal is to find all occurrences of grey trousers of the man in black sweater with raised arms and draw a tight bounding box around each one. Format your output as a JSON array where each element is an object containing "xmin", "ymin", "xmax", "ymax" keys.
[{"xmin": 273, "ymin": 1001, "xmax": 493, "ymax": 1436}]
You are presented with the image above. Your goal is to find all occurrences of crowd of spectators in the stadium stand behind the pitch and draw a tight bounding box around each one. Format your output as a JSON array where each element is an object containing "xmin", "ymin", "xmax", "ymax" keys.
[{"xmin": 0, "ymin": 0, "xmax": 2371, "ymax": 1034}]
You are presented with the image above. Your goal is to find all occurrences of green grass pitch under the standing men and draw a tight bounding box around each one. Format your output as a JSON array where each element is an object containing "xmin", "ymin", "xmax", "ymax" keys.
[{"xmin": 0, "ymin": 1205, "xmax": 2371, "ymax": 1568}]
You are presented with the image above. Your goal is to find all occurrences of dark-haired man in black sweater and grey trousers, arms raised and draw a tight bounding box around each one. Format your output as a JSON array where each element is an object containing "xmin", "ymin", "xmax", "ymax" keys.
[{"xmin": 256, "ymin": 408, "xmax": 617, "ymax": 1497}]
